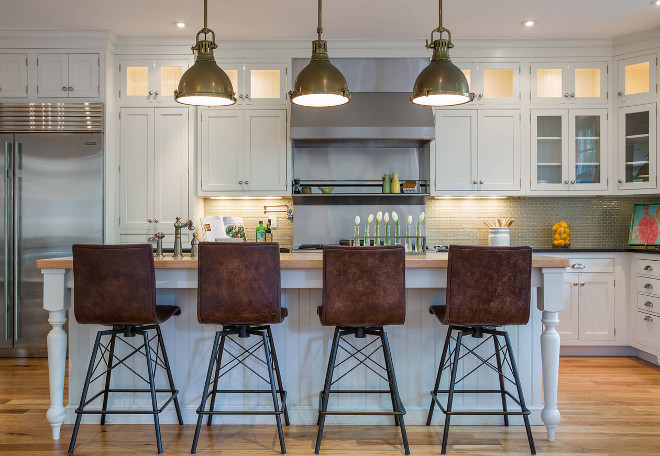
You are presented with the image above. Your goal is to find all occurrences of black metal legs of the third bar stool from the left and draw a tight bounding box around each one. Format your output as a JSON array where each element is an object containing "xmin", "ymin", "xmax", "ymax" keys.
[{"xmin": 314, "ymin": 327, "xmax": 410, "ymax": 454}]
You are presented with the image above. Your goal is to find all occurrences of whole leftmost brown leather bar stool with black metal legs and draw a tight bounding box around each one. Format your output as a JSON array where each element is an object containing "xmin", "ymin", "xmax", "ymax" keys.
[{"xmin": 68, "ymin": 248, "xmax": 183, "ymax": 454}]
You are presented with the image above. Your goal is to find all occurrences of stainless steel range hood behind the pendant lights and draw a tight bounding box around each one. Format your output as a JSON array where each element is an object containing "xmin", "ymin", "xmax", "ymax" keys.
[{"xmin": 291, "ymin": 59, "xmax": 435, "ymax": 141}]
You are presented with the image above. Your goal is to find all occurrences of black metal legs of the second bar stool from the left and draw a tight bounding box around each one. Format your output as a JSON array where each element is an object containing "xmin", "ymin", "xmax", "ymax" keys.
[{"xmin": 195, "ymin": 325, "xmax": 289, "ymax": 454}]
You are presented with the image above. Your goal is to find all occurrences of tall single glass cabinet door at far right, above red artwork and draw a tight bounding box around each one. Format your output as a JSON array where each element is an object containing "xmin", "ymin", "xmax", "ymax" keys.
[{"xmin": 617, "ymin": 103, "xmax": 657, "ymax": 189}]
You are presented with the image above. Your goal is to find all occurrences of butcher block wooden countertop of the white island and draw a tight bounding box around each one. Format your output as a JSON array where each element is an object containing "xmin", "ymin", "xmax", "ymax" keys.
[{"xmin": 37, "ymin": 252, "xmax": 571, "ymax": 269}]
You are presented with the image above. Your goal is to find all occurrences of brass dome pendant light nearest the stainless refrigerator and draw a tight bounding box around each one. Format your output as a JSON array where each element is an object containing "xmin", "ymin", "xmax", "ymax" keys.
[{"xmin": 174, "ymin": 0, "xmax": 236, "ymax": 106}]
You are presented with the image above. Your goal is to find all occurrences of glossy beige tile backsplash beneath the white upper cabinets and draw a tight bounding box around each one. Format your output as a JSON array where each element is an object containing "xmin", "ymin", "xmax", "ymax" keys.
[{"xmin": 204, "ymin": 196, "xmax": 660, "ymax": 248}]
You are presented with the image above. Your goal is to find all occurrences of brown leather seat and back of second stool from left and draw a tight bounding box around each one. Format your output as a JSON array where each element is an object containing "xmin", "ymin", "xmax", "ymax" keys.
[{"xmin": 197, "ymin": 242, "xmax": 284, "ymax": 325}]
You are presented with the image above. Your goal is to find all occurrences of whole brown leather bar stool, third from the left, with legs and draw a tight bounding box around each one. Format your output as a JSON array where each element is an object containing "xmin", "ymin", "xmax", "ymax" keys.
[{"xmin": 314, "ymin": 246, "xmax": 410, "ymax": 454}]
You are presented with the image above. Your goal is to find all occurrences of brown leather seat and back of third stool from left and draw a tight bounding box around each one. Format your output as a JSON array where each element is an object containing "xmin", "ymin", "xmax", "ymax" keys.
[{"xmin": 320, "ymin": 245, "xmax": 406, "ymax": 327}]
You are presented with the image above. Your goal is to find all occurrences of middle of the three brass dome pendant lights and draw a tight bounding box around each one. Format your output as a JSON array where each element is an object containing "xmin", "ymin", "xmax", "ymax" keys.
[{"xmin": 289, "ymin": 0, "xmax": 351, "ymax": 108}]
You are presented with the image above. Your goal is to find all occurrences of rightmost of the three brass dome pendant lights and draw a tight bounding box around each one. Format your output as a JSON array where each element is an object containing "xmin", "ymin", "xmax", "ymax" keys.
[{"xmin": 410, "ymin": 0, "xmax": 474, "ymax": 106}]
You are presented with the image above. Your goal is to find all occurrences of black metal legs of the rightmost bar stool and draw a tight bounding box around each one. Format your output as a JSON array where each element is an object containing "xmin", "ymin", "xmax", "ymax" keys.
[{"xmin": 426, "ymin": 326, "xmax": 536, "ymax": 454}]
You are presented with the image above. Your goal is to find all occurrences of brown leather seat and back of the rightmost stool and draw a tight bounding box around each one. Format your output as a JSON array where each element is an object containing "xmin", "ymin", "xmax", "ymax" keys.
[{"xmin": 441, "ymin": 245, "xmax": 532, "ymax": 326}]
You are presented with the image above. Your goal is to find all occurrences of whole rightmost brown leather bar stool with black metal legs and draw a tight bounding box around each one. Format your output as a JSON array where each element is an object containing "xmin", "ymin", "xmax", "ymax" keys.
[{"xmin": 426, "ymin": 245, "xmax": 536, "ymax": 454}]
